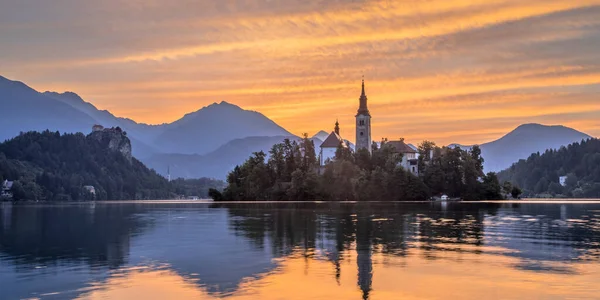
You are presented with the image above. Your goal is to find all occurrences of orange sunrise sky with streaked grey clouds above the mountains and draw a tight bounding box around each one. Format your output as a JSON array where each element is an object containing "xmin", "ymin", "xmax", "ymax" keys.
[{"xmin": 0, "ymin": 0, "xmax": 600, "ymax": 144}]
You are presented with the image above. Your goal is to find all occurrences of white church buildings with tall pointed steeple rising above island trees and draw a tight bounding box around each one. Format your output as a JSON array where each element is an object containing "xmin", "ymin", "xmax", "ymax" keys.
[{"xmin": 319, "ymin": 79, "xmax": 419, "ymax": 175}]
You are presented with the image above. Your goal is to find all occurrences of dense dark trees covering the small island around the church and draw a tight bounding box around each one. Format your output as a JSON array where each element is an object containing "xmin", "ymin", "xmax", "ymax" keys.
[{"xmin": 210, "ymin": 135, "xmax": 502, "ymax": 201}]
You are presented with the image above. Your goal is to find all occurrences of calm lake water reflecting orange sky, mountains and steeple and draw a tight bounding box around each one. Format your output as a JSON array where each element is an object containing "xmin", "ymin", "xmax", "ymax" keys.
[{"xmin": 0, "ymin": 201, "xmax": 600, "ymax": 299}]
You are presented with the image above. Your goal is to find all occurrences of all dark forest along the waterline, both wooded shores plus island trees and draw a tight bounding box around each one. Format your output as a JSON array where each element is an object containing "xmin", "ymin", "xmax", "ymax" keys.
[{"xmin": 0, "ymin": 131, "xmax": 600, "ymax": 201}]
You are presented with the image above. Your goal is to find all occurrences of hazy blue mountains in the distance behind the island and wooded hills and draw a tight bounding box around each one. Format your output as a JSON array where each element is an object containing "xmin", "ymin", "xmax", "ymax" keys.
[{"xmin": 0, "ymin": 76, "xmax": 590, "ymax": 179}]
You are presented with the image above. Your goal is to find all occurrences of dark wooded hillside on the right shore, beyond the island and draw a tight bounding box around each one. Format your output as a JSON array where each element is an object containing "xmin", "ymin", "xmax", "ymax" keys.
[{"xmin": 498, "ymin": 139, "xmax": 600, "ymax": 198}]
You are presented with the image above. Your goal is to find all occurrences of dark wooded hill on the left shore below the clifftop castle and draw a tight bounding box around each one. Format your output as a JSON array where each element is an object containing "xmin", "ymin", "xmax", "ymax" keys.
[{"xmin": 0, "ymin": 131, "xmax": 219, "ymax": 201}]
